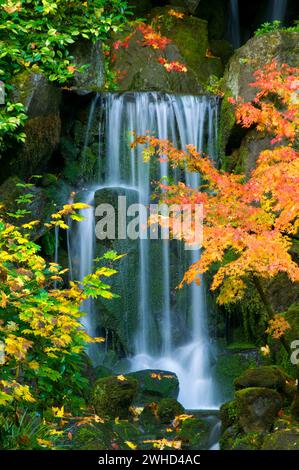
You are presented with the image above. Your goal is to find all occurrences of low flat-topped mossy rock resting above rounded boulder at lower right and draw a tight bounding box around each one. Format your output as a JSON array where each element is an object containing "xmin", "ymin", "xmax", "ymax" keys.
[{"xmin": 234, "ymin": 366, "xmax": 287, "ymax": 392}]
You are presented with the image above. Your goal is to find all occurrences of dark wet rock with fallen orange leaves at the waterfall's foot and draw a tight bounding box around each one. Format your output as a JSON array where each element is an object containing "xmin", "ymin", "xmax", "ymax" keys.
[{"xmin": 126, "ymin": 369, "xmax": 179, "ymax": 405}]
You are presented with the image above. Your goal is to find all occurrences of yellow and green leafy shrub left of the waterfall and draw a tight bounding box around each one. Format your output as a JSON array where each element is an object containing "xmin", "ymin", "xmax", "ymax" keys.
[{"xmin": 0, "ymin": 196, "xmax": 116, "ymax": 406}]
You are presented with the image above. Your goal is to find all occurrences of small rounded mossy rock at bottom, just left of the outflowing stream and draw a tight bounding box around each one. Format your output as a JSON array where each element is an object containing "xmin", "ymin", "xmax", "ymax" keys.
[{"xmin": 177, "ymin": 417, "xmax": 210, "ymax": 450}]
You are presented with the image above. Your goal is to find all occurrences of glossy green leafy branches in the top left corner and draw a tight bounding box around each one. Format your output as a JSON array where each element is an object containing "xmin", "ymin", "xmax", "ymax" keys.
[{"xmin": 0, "ymin": 0, "xmax": 134, "ymax": 148}]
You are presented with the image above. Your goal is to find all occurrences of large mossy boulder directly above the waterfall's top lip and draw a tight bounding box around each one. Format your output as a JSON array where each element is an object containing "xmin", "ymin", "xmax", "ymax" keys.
[{"xmin": 113, "ymin": 7, "xmax": 222, "ymax": 94}]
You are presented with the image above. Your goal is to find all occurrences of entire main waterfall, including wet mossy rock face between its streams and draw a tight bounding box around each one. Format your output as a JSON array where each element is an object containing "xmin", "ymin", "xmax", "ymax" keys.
[{"xmin": 70, "ymin": 92, "xmax": 219, "ymax": 409}]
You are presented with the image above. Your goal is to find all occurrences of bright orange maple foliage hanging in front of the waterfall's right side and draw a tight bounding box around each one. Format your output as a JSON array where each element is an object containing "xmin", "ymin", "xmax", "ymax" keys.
[{"xmin": 134, "ymin": 62, "xmax": 299, "ymax": 337}]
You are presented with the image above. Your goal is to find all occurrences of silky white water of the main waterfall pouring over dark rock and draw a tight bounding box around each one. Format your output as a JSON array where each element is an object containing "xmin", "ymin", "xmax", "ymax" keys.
[{"xmin": 72, "ymin": 92, "xmax": 218, "ymax": 409}]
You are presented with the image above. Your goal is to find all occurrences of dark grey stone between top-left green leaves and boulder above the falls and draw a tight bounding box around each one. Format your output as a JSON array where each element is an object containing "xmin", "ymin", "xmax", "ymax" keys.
[{"xmin": 70, "ymin": 39, "xmax": 105, "ymax": 95}]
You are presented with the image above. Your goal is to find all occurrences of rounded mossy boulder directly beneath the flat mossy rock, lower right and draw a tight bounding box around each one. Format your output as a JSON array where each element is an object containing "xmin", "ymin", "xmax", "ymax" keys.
[{"xmin": 236, "ymin": 387, "xmax": 282, "ymax": 432}]
